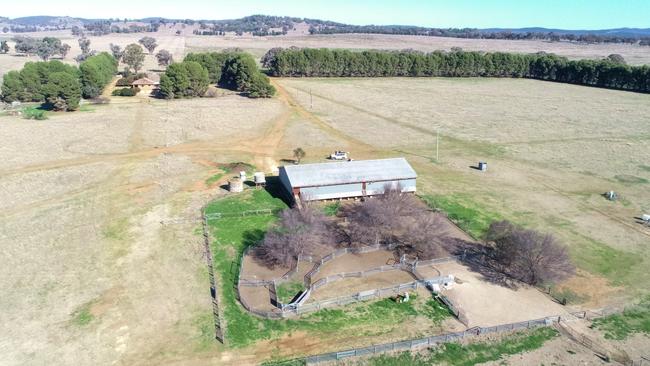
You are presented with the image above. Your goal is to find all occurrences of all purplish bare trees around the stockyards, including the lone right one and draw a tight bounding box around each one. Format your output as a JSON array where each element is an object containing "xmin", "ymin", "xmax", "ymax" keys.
[{"xmin": 253, "ymin": 188, "xmax": 575, "ymax": 285}]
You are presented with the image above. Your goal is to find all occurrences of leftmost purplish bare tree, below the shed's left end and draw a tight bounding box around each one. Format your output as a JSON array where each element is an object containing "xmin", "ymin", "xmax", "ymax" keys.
[{"xmin": 254, "ymin": 204, "xmax": 335, "ymax": 267}]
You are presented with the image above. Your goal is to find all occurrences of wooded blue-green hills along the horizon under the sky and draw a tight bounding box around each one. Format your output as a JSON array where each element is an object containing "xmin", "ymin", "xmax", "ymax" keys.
[{"xmin": 0, "ymin": 15, "xmax": 650, "ymax": 45}]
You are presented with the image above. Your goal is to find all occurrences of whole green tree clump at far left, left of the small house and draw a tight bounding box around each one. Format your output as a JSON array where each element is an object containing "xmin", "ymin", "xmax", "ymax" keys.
[{"xmin": 2, "ymin": 52, "xmax": 117, "ymax": 111}]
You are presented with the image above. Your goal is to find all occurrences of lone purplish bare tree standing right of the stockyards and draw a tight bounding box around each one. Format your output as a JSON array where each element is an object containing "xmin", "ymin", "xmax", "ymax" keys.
[{"xmin": 487, "ymin": 221, "xmax": 575, "ymax": 285}]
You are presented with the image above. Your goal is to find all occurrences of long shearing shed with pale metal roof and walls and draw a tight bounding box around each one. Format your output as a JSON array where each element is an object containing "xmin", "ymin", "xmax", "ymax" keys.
[{"xmin": 280, "ymin": 158, "xmax": 417, "ymax": 201}]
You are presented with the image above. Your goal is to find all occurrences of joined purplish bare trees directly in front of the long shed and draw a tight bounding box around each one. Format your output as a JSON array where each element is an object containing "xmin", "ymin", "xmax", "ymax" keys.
[{"xmin": 254, "ymin": 188, "xmax": 445, "ymax": 267}]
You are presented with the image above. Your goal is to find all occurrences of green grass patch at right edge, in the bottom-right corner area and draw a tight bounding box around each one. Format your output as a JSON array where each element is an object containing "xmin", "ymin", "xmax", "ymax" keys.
[{"xmin": 593, "ymin": 296, "xmax": 650, "ymax": 340}]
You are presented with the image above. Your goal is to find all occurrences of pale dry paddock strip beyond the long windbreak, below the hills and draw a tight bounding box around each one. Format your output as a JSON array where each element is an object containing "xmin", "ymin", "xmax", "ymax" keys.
[{"xmin": 0, "ymin": 25, "xmax": 650, "ymax": 81}]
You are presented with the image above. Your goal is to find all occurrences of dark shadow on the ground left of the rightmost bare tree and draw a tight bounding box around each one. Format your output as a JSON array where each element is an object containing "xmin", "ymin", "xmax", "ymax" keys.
[{"xmin": 442, "ymin": 237, "xmax": 518, "ymax": 289}]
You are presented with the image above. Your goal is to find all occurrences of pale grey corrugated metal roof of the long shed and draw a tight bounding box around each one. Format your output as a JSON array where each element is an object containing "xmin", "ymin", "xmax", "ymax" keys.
[{"xmin": 282, "ymin": 158, "xmax": 417, "ymax": 187}]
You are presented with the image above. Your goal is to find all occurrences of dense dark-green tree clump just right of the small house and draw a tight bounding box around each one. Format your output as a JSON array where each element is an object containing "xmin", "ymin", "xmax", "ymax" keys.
[{"xmin": 160, "ymin": 51, "xmax": 275, "ymax": 99}]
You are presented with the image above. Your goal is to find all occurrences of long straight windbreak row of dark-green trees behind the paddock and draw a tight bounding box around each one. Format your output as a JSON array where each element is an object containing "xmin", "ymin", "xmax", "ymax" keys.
[{"xmin": 264, "ymin": 48, "xmax": 650, "ymax": 92}]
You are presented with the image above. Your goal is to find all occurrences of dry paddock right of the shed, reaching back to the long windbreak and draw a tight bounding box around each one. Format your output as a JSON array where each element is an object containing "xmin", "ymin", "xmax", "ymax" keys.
[{"xmin": 280, "ymin": 78, "xmax": 650, "ymax": 305}]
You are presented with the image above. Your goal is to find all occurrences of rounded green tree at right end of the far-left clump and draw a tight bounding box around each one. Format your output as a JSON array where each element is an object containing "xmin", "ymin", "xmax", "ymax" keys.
[{"xmin": 79, "ymin": 52, "xmax": 117, "ymax": 98}]
